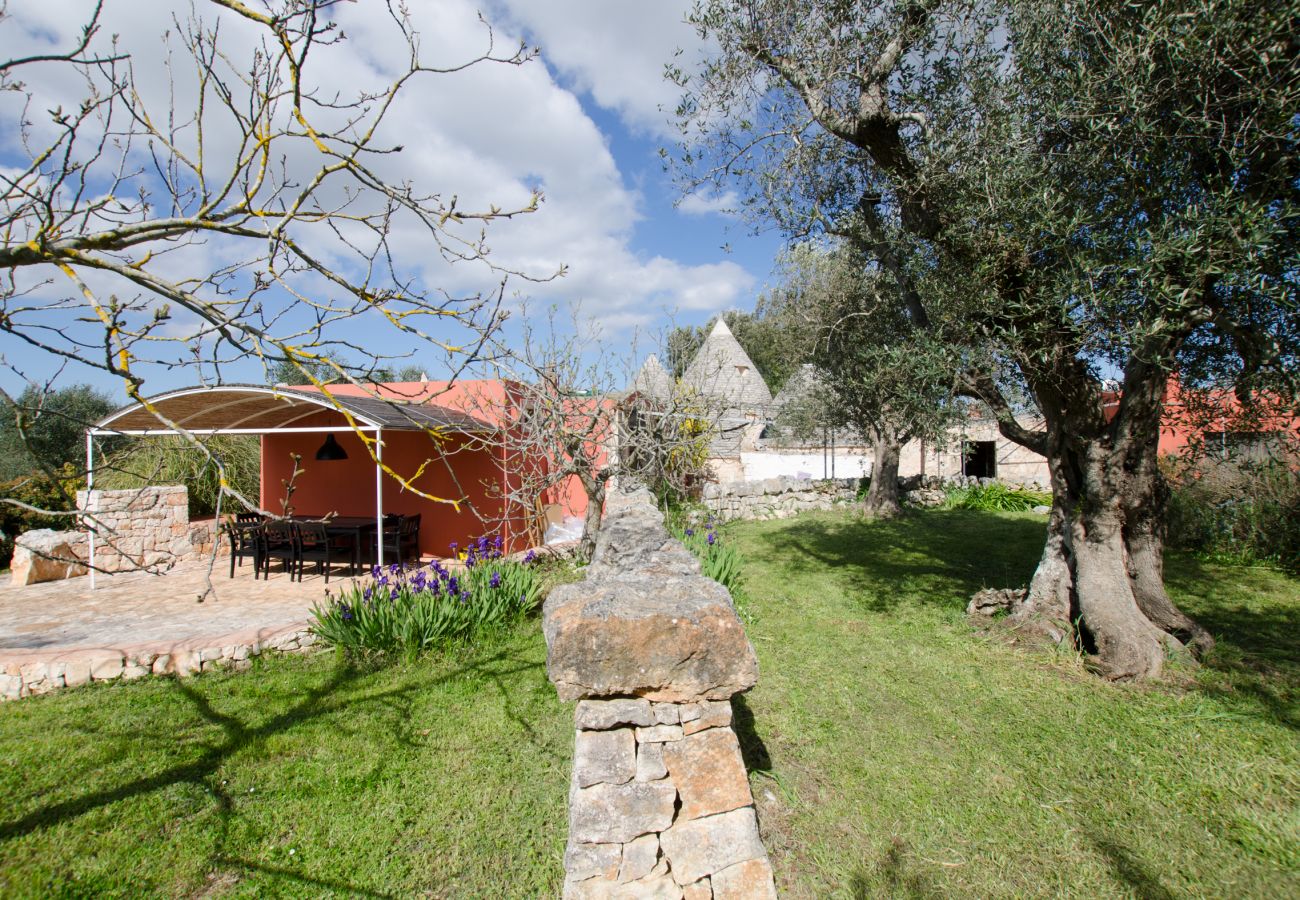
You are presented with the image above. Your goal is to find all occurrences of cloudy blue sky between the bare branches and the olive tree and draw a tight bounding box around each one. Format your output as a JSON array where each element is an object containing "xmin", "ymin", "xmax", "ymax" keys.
[{"xmin": 0, "ymin": 0, "xmax": 779, "ymax": 394}]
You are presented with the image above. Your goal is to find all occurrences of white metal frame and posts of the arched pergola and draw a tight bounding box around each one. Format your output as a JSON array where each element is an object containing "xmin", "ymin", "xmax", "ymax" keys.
[{"xmin": 86, "ymin": 385, "xmax": 408, "ymax": 590}]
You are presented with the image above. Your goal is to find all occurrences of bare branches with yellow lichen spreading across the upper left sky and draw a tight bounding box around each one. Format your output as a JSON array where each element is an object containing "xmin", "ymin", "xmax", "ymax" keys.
[{"xmin": 0, "ymin": 0, "xmax": 554, "ymax": 538}]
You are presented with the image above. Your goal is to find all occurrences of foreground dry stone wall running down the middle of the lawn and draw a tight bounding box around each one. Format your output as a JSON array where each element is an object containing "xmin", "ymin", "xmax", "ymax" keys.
[{"xmin": 543, "ymin": 490, "xmax": 776, "ymax": 900}]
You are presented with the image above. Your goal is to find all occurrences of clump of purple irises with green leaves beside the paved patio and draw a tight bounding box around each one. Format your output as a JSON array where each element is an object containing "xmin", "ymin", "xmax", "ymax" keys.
[{"xmin": 312, "ymin": 537, "xmax": 541, "ymax": 658}]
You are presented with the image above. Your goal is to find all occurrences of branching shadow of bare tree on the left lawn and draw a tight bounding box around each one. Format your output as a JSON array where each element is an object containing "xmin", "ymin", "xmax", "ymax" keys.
[{"xmin": 0, "ymin": 649, "xmax": 541, "ymax": 896}]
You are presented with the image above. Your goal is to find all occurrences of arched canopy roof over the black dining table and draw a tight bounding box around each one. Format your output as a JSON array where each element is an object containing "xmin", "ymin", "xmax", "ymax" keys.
[{"xmin": 91, "ymin": 385, "xmax": 489, "ymax": 434}]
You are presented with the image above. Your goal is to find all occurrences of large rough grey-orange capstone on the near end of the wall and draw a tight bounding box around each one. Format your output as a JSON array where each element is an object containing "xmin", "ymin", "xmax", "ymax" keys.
[{"xmin": 542, "ymin": 572, "xmax": 758, "ymax": 701}]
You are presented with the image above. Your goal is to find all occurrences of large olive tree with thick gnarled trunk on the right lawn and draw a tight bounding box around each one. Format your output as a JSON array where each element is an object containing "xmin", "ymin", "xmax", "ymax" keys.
[{"xmin": 680, "ymin": 0, "xmax": 1300, "ymax": 680}]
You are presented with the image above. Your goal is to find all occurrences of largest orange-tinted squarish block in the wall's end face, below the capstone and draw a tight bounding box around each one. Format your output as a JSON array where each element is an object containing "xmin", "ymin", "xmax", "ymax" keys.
[{"xmin": 663, "ymin": 728, "xmax": 754, "ymax": 821}]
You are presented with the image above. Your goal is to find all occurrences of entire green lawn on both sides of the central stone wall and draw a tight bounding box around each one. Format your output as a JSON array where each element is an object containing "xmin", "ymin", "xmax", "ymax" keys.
[{"xmin": 0, "ymin": 511, "xmax": 1300, "ymax": 897}]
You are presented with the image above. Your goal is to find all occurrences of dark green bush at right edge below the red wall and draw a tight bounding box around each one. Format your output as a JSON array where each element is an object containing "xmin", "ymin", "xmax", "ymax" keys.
[{"xmin": 1166, "ymin": 460, "xmax": 1300, "ymax": 572}]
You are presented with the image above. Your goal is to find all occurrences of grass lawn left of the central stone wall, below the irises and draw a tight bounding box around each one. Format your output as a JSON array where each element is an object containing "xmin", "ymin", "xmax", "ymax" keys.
[{"xmin": 0, "ymin": 629, "xmax": 573, "ymax": 897}]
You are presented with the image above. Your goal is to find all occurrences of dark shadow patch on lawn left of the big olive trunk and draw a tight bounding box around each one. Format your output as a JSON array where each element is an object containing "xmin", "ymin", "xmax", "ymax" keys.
[{"xmin": 753, "ymin": 510, "xmax": 1047, "ymax": 613}]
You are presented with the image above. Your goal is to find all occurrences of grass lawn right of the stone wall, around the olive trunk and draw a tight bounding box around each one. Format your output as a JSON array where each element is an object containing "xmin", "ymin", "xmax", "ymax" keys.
[{"xmin": 728, "ymin": 511, "xmax": 1300, "ymax": 897}]
